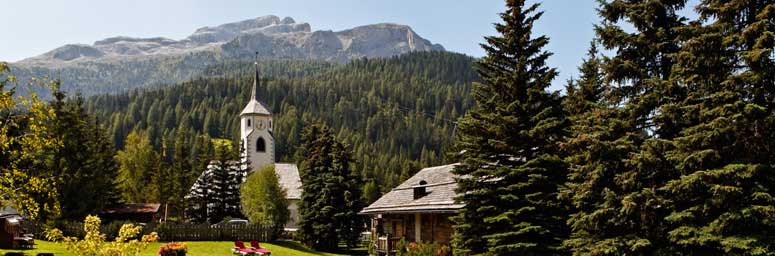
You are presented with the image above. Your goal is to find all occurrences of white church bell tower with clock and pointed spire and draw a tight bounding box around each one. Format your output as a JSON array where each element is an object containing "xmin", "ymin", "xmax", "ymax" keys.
[{"xmin": 240, "ymin": 57, "xmax": 275, "ymax": 172}]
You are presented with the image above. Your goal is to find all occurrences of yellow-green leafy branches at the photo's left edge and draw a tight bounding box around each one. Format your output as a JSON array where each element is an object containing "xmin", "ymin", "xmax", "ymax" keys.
[{"xmin": 0, "ymin": 62, "xmax": 61, "ymax": 220}]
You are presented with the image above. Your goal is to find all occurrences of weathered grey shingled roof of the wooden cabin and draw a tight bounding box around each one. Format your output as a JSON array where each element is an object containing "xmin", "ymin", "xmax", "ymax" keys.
[{"xmin": 361, "ymin": 164, "xmax": 464, "ymax": 214}]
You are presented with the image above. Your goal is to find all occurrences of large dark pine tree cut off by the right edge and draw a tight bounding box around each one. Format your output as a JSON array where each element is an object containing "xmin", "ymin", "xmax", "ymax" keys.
[{"xmin": 660, "ymin": 0, "xmax": 775, "ymax": 255}]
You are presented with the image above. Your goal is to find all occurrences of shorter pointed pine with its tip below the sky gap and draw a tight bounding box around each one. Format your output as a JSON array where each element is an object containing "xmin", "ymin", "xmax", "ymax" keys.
[{"xmin": 561, "ymin": 42, "xmax": 634, "ymax": 255}]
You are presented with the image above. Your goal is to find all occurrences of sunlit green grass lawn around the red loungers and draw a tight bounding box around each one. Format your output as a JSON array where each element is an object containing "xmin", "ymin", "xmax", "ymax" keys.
[{"xmin": 0, "ymin": 240, "xmax": 366, "ymax": 256}]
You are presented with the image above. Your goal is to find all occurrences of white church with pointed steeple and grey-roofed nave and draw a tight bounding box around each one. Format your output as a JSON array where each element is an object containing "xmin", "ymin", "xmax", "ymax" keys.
[{"xmin": 239, "ymin": 62, "xmax": 301, "ymax": 231}]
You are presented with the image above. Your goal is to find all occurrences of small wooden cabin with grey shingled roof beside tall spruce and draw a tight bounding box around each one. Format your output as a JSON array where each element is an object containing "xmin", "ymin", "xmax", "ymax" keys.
[{"xmin": 360, "ymin": 164, "xmax": 464, "ymax": 255}]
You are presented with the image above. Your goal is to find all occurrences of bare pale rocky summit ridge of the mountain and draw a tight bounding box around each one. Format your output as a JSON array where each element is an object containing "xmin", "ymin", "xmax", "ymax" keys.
[{"xmin": 17, "ymin": 15, "xmax": 444, "ymax": 66}]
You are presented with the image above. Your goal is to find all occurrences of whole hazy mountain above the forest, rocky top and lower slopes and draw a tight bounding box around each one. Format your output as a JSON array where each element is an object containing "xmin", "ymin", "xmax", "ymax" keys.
[{"xmin": 11, "ymin": 15, "xmax": 444, "ymax": 95}]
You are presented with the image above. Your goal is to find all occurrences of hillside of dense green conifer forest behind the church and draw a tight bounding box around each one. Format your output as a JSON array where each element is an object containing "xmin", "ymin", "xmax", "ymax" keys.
[{"xmin": 86, "ymin": 52, "xmax": 477, "ymax": 190}]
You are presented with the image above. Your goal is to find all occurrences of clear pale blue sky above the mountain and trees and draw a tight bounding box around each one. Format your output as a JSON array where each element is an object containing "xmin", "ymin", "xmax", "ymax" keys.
[{"xmin": 0, "ymin": 0, "xmax": 598, "ymax": 89}]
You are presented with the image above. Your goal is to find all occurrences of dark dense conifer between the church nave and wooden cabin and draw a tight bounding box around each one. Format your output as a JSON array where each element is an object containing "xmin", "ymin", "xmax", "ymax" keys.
[{"xmin": 299, "ymin": 124, "xmax": 363, "ymax": 251}]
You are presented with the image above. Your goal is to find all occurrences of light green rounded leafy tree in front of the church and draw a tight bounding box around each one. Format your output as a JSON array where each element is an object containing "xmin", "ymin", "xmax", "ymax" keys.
[{"xmin": 240, "ymin": 165, "xmax": 290, "ymax": 237}]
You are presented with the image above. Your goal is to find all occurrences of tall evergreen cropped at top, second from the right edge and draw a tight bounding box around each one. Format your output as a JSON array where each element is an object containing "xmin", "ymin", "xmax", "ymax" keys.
[{"xmin": 565, "ymin": 0, "xmax": 686, "ymax": 255}]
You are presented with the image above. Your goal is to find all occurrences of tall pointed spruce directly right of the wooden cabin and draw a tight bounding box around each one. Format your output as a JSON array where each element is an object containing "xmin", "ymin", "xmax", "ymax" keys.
[{"xmin": 454, "ymin": 0, "xmax": 568, "ymax": 255}]
